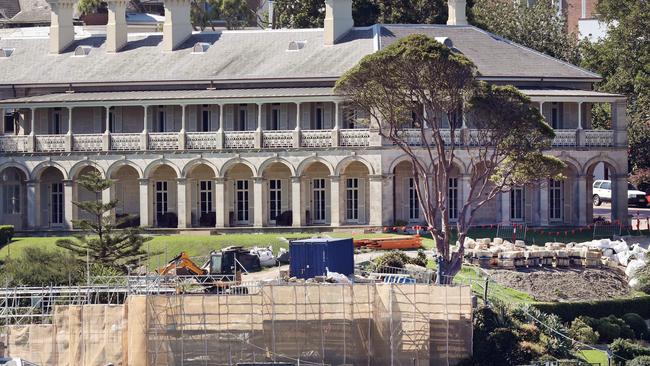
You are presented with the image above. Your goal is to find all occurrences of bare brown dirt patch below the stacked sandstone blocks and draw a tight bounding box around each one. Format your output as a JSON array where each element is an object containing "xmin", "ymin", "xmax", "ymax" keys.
[{"xmin": 488, "ymin": 268, "xmax": 631, "ymax": 301}]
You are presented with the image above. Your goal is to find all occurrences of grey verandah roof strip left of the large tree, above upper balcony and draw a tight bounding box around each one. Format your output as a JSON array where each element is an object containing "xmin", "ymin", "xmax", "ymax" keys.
[{"xmin": 0, "ymin": 87, "xmax": 342, "ymax": 108}]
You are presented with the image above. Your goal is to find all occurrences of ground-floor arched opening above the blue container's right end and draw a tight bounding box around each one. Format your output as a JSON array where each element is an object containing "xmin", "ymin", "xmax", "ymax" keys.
[{"xmin": 339, "ymin": 161, "xmax": 370, "ymax": 225}]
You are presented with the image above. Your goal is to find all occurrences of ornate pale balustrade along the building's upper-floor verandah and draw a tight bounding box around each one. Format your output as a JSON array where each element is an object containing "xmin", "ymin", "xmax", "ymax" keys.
[{"xmin": 0, "ymin": 129, "xmax": 616, "ymax": 153}]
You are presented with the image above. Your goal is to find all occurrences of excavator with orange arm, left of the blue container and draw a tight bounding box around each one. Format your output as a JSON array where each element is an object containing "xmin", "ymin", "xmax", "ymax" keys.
[{"xmin": 156, "ymin": 247, "xmax": 261, "ymax": 294}]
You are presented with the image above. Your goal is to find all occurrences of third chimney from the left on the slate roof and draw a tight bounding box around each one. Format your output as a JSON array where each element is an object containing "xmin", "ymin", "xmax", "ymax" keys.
[{"xmin": 163, "ymin": 0, "xmax": 192, "ymax": 51}]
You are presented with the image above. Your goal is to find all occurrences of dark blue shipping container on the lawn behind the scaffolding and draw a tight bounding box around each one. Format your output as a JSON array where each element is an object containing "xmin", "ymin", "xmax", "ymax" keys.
[{"xmin": 289, "ymin": 238, "xmax": 354, "ymax": 279}]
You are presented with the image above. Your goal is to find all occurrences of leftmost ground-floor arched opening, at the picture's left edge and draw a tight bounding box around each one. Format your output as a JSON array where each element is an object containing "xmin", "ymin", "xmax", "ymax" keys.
[{"xmin": 0, "ymin": 167, "xmax": 27, "ymax": 230}]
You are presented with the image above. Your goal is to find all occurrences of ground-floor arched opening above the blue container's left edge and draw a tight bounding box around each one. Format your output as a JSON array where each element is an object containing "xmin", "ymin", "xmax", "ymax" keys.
[{"xmin": 262, "ymin": 162, "xmax": 292, "ymax": 226}]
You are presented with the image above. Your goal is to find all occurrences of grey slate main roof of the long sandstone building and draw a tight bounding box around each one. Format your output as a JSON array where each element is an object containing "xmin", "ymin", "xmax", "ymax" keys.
[{"xmin": 0, "ymin": 25, "xmax": 598, "ymax": 85}]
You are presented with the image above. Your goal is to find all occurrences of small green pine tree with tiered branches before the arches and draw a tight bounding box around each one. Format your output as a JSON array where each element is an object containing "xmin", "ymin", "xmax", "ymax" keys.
[{"xmin": 56, "ymin": 171, "xmax": 151, "ymax": 272}]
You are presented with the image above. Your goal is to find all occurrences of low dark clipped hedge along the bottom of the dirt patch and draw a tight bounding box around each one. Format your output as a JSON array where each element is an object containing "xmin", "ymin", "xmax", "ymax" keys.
[{"xmin": 533, "ymin": 295, "xmax": 650, "ymax": 322}]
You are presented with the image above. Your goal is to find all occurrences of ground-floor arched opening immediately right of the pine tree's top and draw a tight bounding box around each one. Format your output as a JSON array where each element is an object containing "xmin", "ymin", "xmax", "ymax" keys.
[{"xmin": 109, "ymin": 165, "xmax": 140, "ymax": 226}]
